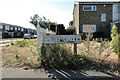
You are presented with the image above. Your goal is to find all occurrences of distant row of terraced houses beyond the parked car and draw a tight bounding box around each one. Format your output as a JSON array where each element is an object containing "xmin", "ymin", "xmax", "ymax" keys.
[{"xmin": 0, "ymin": 23, "xmax": 36, "ymax": 39}]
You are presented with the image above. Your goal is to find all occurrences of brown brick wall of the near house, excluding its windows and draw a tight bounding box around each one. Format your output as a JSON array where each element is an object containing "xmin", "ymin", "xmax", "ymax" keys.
[{"xmin": 79, "ymin": 4, "xmax": 112, "ymax": 37}]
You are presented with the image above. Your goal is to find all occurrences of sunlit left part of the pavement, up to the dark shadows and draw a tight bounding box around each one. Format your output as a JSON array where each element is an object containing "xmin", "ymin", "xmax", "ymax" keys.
[{"xmin": 2, "ymin": 68, "xmax": 48, "ymax": 78}]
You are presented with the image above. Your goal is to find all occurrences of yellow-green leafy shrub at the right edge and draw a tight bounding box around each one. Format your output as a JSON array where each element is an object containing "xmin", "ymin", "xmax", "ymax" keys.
[{"xmin": 111, "ymin": 25, "xmax": 120, "ymax": 58}]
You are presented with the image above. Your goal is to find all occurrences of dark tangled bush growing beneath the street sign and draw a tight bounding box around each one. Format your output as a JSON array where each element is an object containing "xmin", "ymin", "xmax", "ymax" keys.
[{"xmin": 41, "ymin": 44, "xmax": 88, "ymax": 69}]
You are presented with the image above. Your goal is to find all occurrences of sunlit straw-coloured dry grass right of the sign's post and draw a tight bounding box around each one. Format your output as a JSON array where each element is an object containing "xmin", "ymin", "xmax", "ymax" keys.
[{"xmin": 77, "ymin": 41, "xmax": 118, "ymax": 63}]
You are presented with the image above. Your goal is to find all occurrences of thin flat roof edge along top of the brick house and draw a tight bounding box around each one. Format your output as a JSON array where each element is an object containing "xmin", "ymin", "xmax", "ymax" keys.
[{"xmin": 75, "ymin": 1, "xmax": 120, "ymax": 4}]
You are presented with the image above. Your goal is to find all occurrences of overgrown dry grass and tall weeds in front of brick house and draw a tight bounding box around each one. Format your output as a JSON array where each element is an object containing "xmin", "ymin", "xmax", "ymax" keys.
[{"xmin": 78, "ymin": 33, "xmax": 120, "ymax": 73}]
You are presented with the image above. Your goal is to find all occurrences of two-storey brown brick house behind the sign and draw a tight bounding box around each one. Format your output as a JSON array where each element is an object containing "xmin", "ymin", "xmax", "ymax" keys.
[{"xmin": 73, "ymin": 1, "xmax": 120, "ymax": 38}]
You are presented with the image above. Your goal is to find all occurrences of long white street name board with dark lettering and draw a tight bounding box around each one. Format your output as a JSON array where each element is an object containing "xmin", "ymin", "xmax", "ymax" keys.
[{"xmin": 42, "ymin": 35, "xmax": 81, "ymax": 44}]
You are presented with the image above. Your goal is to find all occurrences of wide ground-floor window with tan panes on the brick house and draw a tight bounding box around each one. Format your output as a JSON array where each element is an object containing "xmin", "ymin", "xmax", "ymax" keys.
[{"xmin": 83, "ymin": 24, "xmax": 96, "ymax": 33}]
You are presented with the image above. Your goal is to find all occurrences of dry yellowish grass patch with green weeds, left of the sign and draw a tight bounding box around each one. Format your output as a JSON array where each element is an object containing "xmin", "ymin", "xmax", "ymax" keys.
[{"xmin": 2, "ymin": 40, "xmax": 39, "ymax": 68}]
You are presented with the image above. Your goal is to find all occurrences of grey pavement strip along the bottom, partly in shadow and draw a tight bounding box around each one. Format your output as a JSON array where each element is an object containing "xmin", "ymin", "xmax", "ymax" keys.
[{"xmin": 2, "ymin": 68, "xmax": 120, "ymax": 80}]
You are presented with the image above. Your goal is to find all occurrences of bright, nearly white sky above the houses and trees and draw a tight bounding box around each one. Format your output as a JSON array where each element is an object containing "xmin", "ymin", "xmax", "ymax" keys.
[{"xmin": 0, "ymin": 0, "xmax": 118, "ymax": 28}]
